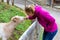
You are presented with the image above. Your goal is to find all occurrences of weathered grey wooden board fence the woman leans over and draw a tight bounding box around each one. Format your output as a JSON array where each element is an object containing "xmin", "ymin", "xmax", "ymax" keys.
[{"xmin": 19, "ymin": 21, "xmax": 43, "ymax": 40}]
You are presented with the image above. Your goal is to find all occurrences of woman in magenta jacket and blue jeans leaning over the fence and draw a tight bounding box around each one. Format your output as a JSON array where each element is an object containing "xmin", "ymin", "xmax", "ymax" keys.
[{"xmin": 25, "ymin": 5, "xmax": 58, "ymax": 40}]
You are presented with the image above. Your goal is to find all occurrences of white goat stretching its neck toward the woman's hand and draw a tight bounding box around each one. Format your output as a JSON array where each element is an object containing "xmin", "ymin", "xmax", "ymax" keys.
[{"xmin": 0, "ymin": 16, "xmax": 24, "ymax": 40}]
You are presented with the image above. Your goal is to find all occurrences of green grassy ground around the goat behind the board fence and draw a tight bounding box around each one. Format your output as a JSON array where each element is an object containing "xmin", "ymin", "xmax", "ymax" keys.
[{"xmin": 0, "ymin": 3, "xmax": 31, "ymax": 40}]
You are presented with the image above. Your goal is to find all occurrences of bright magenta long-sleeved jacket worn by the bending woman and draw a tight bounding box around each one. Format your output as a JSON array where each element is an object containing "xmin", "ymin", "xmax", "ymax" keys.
[{"xmin": 29, "ymin": 5, "xmax": 58, "ymax": 32}]
